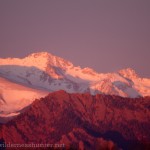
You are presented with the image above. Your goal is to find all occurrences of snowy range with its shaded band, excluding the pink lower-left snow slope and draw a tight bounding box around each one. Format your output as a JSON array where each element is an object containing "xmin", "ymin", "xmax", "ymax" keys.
[{"xmin": 0, "ymin": 52, "xmax": 150, "ymax": 97}]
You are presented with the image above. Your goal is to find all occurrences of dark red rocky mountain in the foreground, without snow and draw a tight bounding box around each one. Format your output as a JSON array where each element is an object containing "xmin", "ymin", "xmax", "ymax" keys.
[{"xmin": 0, "ymin": 91, "xmax": 150, "ymax": 150}]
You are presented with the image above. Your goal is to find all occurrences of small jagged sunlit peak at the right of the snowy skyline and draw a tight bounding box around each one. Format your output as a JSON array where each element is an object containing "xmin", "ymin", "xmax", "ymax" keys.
[{"xmin": 118, "ymin": 68, "xmax": 138, "ymax": 78}]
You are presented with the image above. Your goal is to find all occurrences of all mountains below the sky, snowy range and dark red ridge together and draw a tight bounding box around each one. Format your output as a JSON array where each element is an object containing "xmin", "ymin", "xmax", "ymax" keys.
[{"xmin": 0, "ymin": 52, "xmax": 150, "ymax": 150}]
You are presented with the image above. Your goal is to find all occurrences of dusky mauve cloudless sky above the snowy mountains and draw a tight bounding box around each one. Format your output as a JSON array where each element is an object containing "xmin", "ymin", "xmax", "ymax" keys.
[{"xmin": 0, "ymin": 0, "xmax": 150, "ymax": 77}]
